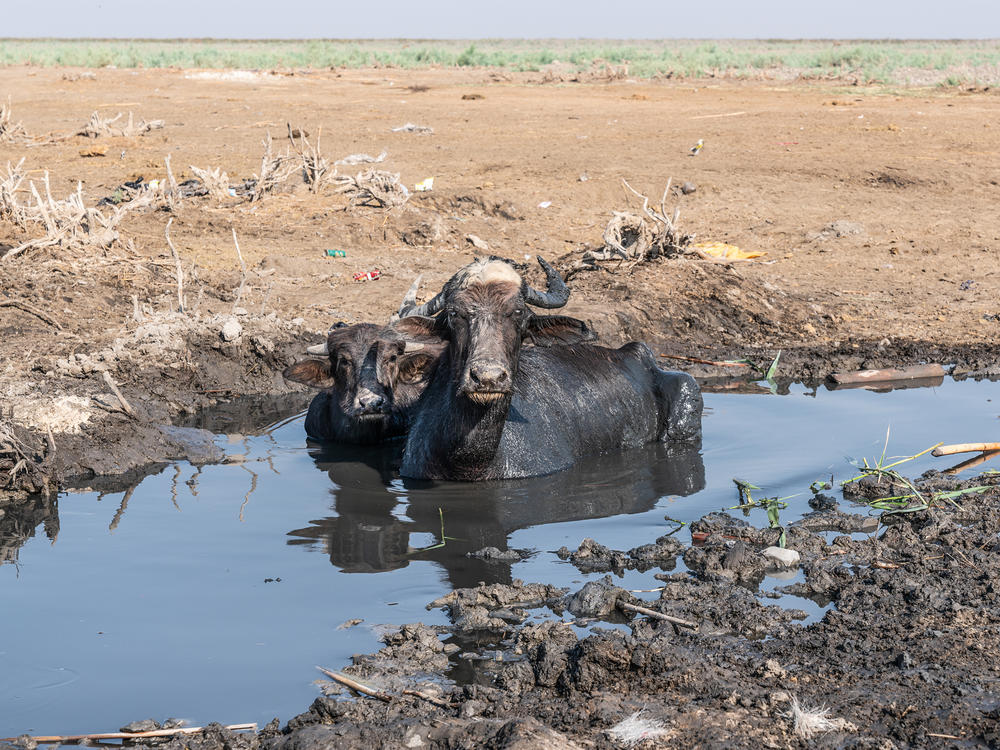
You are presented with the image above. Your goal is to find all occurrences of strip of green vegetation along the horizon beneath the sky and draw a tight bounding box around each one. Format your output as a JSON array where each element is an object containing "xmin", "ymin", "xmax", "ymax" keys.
[{"xmin": 0, "ymin": 39, "xmax": 1000, "ymax": 85}]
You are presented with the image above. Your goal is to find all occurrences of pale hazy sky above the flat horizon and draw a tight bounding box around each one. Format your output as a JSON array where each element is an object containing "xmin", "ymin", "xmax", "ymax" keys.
[{"xmin": 0, "ymin": 0, "xmax": 1000, "ymax": 39}]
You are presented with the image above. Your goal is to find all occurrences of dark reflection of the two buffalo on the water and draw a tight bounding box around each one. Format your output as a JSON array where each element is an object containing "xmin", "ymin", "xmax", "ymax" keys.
[{"xmin": 288, "ymin": 443, "xmax": 705, "ymax": 588}]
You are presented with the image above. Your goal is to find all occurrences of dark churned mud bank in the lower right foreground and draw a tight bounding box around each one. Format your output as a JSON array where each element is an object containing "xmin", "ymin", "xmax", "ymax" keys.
[{"xmin": 41, "ymin": 472, "xmax": 1000, "ymax": 750}]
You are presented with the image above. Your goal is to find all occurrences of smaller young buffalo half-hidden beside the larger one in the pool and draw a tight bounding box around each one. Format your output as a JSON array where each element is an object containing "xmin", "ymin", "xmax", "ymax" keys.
[{"xmin": 284, "ymin": 279, "xmax": 445, "ymax": 443}]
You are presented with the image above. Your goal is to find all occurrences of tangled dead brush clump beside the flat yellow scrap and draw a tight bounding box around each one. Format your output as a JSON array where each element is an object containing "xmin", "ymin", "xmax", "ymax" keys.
[{"xmin": 570, "ymin": 179, "xmax": 694, "ymax": 273}]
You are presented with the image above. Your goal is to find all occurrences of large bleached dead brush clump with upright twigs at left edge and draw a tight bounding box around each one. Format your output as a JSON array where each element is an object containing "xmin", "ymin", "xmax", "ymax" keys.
[{"xmin": 0, "ymin": 170, "xmax": 163, "ymax": 260}]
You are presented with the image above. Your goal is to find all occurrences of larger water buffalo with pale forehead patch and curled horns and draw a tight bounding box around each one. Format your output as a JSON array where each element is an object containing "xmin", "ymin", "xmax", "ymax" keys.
[{"xmin": 398, "ymin": 257, "xmax": 702, "ymax": 480}]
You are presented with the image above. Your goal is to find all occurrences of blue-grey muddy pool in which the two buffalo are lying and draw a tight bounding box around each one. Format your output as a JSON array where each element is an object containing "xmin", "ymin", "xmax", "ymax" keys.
[{"xmin": 0, "ymin": 381, "xmax": 1000, "ymax": 737}]
